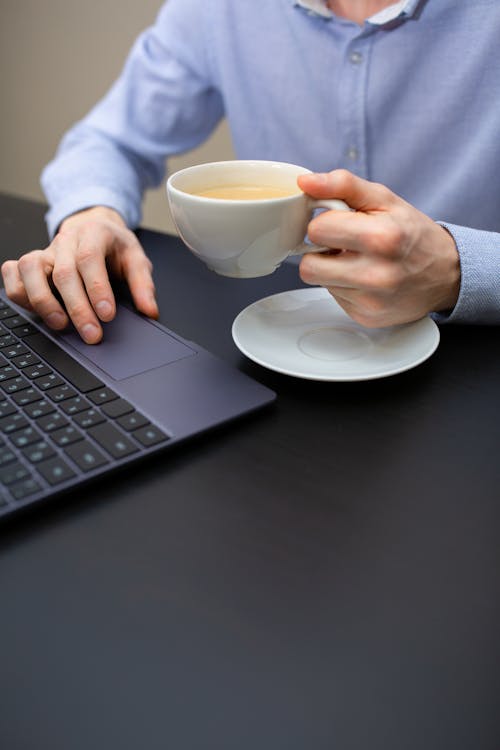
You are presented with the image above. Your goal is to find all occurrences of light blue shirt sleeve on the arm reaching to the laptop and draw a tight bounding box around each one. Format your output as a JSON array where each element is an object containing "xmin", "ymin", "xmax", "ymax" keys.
[{"xmin": 41, "ymin": 0, "xmax": 224, "ymax": 237}]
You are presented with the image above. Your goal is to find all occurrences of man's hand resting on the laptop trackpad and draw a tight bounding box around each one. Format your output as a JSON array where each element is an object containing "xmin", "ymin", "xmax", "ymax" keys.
[{"xmin": 1, "ymin": 206, "xmax": 158, "ymax": 344}]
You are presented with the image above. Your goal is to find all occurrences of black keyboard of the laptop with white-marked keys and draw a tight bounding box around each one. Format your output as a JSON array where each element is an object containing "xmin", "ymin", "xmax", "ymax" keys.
[{"xmin": 0, "ymin": 299, "xmax": 170, "ymax": 516}]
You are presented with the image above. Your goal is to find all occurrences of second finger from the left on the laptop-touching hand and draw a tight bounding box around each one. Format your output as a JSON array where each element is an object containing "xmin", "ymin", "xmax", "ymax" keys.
[{"xmin": 7, "ymin": 249, "xmax": 68, "ymax": 330}]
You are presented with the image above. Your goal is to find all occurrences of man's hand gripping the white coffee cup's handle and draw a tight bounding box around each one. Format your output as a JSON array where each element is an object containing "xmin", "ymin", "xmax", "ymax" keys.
[{"xmin": 299, "ymin": 169, "xmax": 460, "ymax": 328}]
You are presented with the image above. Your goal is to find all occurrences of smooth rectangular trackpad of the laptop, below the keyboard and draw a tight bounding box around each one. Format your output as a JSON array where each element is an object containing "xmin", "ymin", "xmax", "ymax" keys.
[{"xmin": 61, "ymin": 305, "xmax": 196, "ymax": 380}]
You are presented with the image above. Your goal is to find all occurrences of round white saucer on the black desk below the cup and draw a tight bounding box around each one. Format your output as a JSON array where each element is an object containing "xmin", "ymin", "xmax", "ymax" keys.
[{"xmin": 232, "ymin": 287, "xmax": 439, "ymax": 380}]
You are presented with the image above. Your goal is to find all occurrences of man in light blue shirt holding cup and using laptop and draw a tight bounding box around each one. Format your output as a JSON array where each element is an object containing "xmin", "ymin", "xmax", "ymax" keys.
[{"xmin": 2, "ymin": 0, "xmax": 500, "ymax": 343}]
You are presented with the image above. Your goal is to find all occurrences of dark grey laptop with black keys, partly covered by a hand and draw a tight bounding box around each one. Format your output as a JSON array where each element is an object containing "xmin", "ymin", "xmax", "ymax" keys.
[{"xmin": 0, "ymin": 290, "xmax": 276, "ymax": 518}]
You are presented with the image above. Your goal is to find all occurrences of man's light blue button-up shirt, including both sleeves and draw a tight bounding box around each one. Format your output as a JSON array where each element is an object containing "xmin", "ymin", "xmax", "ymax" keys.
[{"xmin": 42, "ymin": 0, "xmax": 500, "ymax": 323}]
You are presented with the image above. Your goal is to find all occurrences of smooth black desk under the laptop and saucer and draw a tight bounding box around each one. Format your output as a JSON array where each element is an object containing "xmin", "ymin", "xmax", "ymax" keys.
[{"xmin": 0, "ymin": 197, "xmax": 500, "ymax": 750}]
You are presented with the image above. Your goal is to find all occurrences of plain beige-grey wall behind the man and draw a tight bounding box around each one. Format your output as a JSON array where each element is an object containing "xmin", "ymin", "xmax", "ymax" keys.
[{"xmin": 0, "ymin": 0, "xmax": 233, "ymax": 231}]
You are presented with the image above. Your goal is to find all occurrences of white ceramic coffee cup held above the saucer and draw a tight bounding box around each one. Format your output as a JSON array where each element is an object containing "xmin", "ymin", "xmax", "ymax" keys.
[{"xmin": 167, "ymin": 160, "xmax": 350, "ymax": 278}]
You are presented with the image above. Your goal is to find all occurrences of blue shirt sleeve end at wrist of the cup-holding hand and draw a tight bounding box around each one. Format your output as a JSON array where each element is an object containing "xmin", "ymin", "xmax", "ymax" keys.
[{"xmin": 433, "ymin": 222, "xmax": 500, "ymax": 324}]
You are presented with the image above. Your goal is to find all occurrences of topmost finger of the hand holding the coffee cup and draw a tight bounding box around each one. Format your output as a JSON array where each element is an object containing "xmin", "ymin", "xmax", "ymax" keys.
[{"xmin": 298, "ymin": 169, "xmax": 397, "ymax": 211}]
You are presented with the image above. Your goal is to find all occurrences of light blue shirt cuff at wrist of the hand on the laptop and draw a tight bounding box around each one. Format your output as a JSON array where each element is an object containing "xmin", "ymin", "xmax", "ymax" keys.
[{"xmin": 45, "ymin": 187, "xmax": 141, "ymax": 239}]
